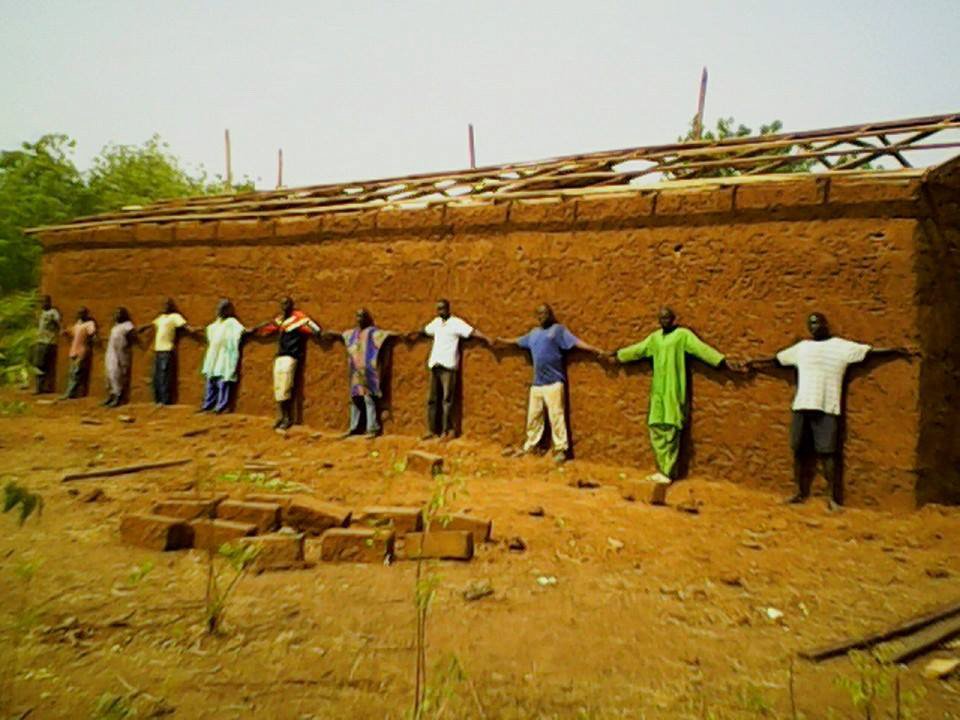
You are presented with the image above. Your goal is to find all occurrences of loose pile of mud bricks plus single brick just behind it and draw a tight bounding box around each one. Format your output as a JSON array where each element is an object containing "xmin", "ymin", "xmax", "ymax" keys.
[{"xmin": 120, "ymin": 451, "xmax": 493, "ymax": 570}]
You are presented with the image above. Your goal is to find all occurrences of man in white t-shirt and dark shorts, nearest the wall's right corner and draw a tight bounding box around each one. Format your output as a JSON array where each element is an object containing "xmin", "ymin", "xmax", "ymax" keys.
[{"xmin": 748, "ymin": 312, "xmax": 911, "ymax": 510}]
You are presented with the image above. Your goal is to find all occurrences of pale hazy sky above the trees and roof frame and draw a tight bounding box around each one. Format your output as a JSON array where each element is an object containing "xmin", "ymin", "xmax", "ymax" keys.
[{"xmin": 0, "ymin": 0, "xmax": 960, "ymax": 188}]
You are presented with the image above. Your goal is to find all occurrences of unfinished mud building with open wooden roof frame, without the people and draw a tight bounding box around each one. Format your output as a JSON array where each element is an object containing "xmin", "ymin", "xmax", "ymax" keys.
[{"xmin": 35, "ymin": 115, "xmax": 960, "ymax": 507}]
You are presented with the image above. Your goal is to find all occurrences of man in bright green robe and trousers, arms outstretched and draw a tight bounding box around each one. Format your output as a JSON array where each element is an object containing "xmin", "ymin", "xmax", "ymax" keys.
[{"xmin": 613, "ymin": 307, "xmax": 740, "ymax": 483}]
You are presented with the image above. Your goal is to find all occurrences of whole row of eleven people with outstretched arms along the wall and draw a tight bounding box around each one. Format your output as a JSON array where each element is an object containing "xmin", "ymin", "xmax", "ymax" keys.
[{"xmin": 35, "ymin": 296, "xmax": 916, "ymax": 508}]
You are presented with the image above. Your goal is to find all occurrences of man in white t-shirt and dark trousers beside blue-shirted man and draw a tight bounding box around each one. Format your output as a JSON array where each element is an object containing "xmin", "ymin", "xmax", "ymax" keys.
[{"xmin": 412, "ymin": 299, "xmax": 492, "ymax": 440}]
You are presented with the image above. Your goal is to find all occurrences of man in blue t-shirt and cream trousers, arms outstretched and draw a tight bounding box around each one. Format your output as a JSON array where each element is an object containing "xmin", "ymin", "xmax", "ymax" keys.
[{"xmin": 497, "ymin": 304, "xmax": 604, "ymax": 463}]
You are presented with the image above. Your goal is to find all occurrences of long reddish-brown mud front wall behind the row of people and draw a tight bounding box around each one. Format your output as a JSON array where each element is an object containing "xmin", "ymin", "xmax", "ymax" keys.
[{"xmin": 42, "ymin": 176, "xmax": 957, "ymax": 506}]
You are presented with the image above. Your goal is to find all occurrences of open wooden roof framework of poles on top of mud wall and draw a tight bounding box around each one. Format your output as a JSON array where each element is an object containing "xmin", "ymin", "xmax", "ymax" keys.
[{"xmin": 28, "ymin": 113, "xmax": 960, "ymax": 232}]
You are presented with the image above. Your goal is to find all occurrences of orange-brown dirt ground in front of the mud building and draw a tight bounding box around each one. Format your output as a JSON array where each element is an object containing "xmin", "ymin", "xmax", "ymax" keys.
[{"xmin": 0, "ymin": 392, "xmax": 960, "ymax": 720}]
